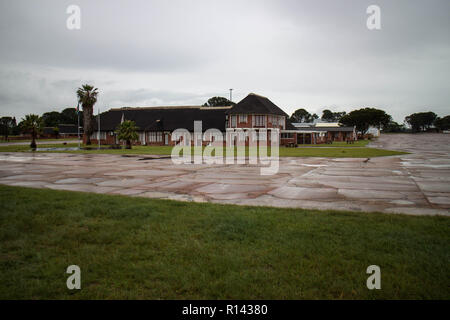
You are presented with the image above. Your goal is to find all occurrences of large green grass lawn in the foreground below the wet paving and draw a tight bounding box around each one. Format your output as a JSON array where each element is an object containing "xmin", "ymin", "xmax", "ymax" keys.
[{"xmin": 0, "ymin": 186, "xmax": 450, "ymax": 299}]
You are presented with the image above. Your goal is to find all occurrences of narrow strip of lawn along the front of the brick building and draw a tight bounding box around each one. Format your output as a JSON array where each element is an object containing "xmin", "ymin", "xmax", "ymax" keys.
[{"xmin": 0, "ymin": 143, "xmax": 406, "ymax": 158}]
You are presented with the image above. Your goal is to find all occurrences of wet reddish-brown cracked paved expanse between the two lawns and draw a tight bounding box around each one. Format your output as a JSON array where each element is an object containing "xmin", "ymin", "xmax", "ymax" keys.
[{"xmin": 0, "ymin": 134, "xmax": 450, "ymax": 216}]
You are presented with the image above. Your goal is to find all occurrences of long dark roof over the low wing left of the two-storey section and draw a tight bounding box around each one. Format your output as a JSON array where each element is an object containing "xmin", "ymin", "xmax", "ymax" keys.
[{"xmin": 94, "ymin": 106, "xmax": 230, "ymax": 131}]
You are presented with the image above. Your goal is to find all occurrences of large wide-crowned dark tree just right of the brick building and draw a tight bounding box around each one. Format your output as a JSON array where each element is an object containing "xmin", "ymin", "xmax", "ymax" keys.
[{"xmin": 339, "ymin": 108, "xmax": 392, "ymax": 135}]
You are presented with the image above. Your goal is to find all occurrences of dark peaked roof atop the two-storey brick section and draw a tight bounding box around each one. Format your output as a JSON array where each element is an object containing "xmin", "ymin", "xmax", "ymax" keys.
[{"xmin": 226, "ymin": 93, "xmax": 288, "ymax": 117}]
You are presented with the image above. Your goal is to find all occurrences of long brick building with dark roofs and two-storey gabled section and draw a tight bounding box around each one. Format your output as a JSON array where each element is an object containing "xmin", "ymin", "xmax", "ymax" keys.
[{"xmin": 84, "ymin": 93, "xmax": 355, "ymax": 146}]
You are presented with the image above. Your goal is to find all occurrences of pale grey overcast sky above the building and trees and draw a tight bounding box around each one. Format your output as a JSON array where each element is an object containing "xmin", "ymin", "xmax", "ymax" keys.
[{"xmin": 0, "ymin": 0, "xmax": 450, "ymax": 122}]
